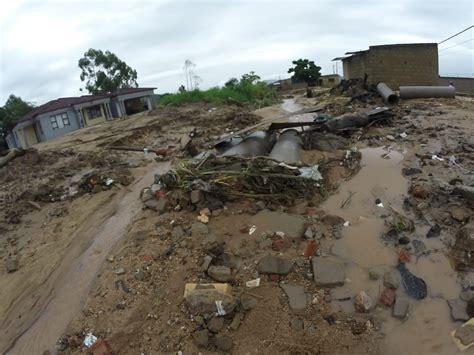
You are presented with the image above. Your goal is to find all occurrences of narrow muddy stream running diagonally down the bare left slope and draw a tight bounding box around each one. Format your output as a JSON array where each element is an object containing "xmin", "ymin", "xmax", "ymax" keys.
[{"xmin": 8, "ymin": 163, "xmax": 169, "ymax": 354}]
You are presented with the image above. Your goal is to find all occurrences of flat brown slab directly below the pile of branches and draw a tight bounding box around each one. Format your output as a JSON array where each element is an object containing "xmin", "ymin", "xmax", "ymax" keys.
[{"xmin": 250, "ymin": 210, "xmax": 306, "ymax": 240}]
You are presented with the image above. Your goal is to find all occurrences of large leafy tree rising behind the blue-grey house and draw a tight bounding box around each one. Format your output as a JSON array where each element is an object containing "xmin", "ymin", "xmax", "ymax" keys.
[{"xmin": 79, "ymin": 48, "xmax": 138, "ymax": 94}]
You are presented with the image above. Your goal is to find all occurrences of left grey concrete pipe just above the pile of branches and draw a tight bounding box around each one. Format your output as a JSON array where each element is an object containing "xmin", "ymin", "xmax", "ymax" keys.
[{"xmin": 221, "ymin": 131, "xmax": 276, "ymax": 157}]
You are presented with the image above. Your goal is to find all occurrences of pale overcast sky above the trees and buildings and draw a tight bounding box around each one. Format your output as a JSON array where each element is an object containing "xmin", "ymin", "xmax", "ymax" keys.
[{"xmin": 0, "ymin": 0, "xmax": 474, "ymax": 105}]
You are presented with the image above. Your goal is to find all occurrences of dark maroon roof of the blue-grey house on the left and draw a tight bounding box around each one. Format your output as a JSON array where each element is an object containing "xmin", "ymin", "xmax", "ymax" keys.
[{"xmin": 17, "ymin": 88, "xmax": 156, "ymax": 123}]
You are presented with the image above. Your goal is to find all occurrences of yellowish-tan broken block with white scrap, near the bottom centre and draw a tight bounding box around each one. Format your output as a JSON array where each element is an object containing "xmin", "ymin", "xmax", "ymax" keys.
[{"xmin": 186, "ymin": 289, "xmax": 235, "ymax": 314}]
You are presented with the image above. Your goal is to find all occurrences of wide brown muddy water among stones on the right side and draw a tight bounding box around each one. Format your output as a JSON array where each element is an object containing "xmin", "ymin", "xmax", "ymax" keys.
[{"xmin": 322, "ymin": 148, "xmax": 460, "ymax": 355}]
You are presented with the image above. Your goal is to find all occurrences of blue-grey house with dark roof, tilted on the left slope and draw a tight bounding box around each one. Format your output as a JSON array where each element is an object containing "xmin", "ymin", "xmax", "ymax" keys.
[{"xmin": 6, "ymin": 88, "xmax": 155, "ymax": 149}]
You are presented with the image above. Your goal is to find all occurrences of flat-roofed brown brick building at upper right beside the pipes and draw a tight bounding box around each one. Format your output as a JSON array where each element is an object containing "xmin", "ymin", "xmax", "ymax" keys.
[{"xmin": 333, "ymin": 43, "xmax": 439, "ymax": 90}]
